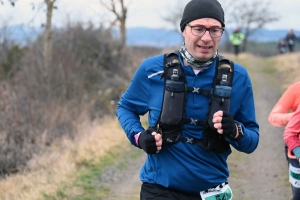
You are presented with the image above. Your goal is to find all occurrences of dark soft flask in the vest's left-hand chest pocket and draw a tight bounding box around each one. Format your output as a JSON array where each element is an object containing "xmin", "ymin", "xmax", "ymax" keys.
[{"xmin": 160, "ymin": 69, "xmax": 185, "ymax": 125}]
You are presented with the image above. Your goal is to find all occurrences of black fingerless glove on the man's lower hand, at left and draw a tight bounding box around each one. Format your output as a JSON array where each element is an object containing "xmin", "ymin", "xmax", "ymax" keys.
[{"xmin": 138, "ymin": 128, "xmax": 157, "ymax": 154}]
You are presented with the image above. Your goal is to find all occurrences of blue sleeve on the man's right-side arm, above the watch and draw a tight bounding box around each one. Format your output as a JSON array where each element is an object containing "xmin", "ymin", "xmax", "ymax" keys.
[{"xmin": 229, "ymin": 71, "xmax": 259, "ymax": 154}]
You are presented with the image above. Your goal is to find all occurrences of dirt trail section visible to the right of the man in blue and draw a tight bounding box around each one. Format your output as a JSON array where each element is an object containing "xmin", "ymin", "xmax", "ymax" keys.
[{"xmin": 229, "ymin": 55, "xmax": 291, "ymax": 200}]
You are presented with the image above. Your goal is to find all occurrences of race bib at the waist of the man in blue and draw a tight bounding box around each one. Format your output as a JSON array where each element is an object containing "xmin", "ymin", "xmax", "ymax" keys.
[{"xmin": 200, "ymin": 183, "xmax": 233, "ymax": 200}]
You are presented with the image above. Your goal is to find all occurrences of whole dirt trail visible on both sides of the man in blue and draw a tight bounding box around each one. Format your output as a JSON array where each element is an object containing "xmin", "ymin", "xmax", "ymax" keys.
[{"xmin": 106, "ymin": 54, "xmax": 291, "ymax": 200}]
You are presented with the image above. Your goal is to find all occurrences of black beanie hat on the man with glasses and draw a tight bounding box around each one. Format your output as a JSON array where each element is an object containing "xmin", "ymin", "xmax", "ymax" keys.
[{"xmin": 180, "ymin": 0, "xmax": 225, "ymax": 32}]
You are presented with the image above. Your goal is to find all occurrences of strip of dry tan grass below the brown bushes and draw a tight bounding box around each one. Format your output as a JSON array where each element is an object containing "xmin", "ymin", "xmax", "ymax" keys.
[{"xmin": 0, "ymin": 119, "xmax": 127, "ymax": 200}]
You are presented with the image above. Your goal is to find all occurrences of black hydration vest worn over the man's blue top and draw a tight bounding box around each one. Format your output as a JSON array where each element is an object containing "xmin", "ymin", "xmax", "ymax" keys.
[{"xmin": 155, "ymin": 51, "xmax": 234, "ymax": 153}]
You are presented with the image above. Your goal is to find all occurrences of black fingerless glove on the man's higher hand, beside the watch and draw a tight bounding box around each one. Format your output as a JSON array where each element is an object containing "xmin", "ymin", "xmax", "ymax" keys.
[{"xmin": 221, "ymin": 111, "xmax": 237, "ymax": 139}]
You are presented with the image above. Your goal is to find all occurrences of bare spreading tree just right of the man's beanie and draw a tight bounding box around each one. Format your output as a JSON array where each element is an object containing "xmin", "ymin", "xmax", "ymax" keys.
[{"xmin": 223, "ymin": 0, "xmax": 278, "ymax": 51}]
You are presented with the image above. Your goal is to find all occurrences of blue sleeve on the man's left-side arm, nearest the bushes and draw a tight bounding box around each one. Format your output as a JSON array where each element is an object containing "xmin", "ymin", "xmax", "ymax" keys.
[{"xmin": 116, "ymin": 62, "xmax": 150, "ymax": 146}]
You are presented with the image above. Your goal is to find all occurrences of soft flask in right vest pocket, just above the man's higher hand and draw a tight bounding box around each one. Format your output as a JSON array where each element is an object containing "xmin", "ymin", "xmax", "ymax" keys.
[{"xmin": 208, "ymin": 74, "xmax": 231, "ymax": 129}]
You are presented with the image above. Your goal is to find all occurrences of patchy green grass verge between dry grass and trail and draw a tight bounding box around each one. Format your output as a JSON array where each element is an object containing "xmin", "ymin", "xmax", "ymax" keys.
[{"xmin": 43, "ymin": 144, "xmax": 141, "ymax": 200}]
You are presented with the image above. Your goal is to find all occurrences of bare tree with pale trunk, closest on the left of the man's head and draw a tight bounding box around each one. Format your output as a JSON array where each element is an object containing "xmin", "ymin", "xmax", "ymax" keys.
[{"xmin": 100, "ymin": 0, "xmax": 128, "ymax": 46}]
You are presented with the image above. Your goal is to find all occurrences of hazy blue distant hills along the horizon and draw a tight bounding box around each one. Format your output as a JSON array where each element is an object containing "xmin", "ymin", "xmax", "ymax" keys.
[{"xmin": 0, "ymin": 25, "xmax": 300, "ymax": 47}]
